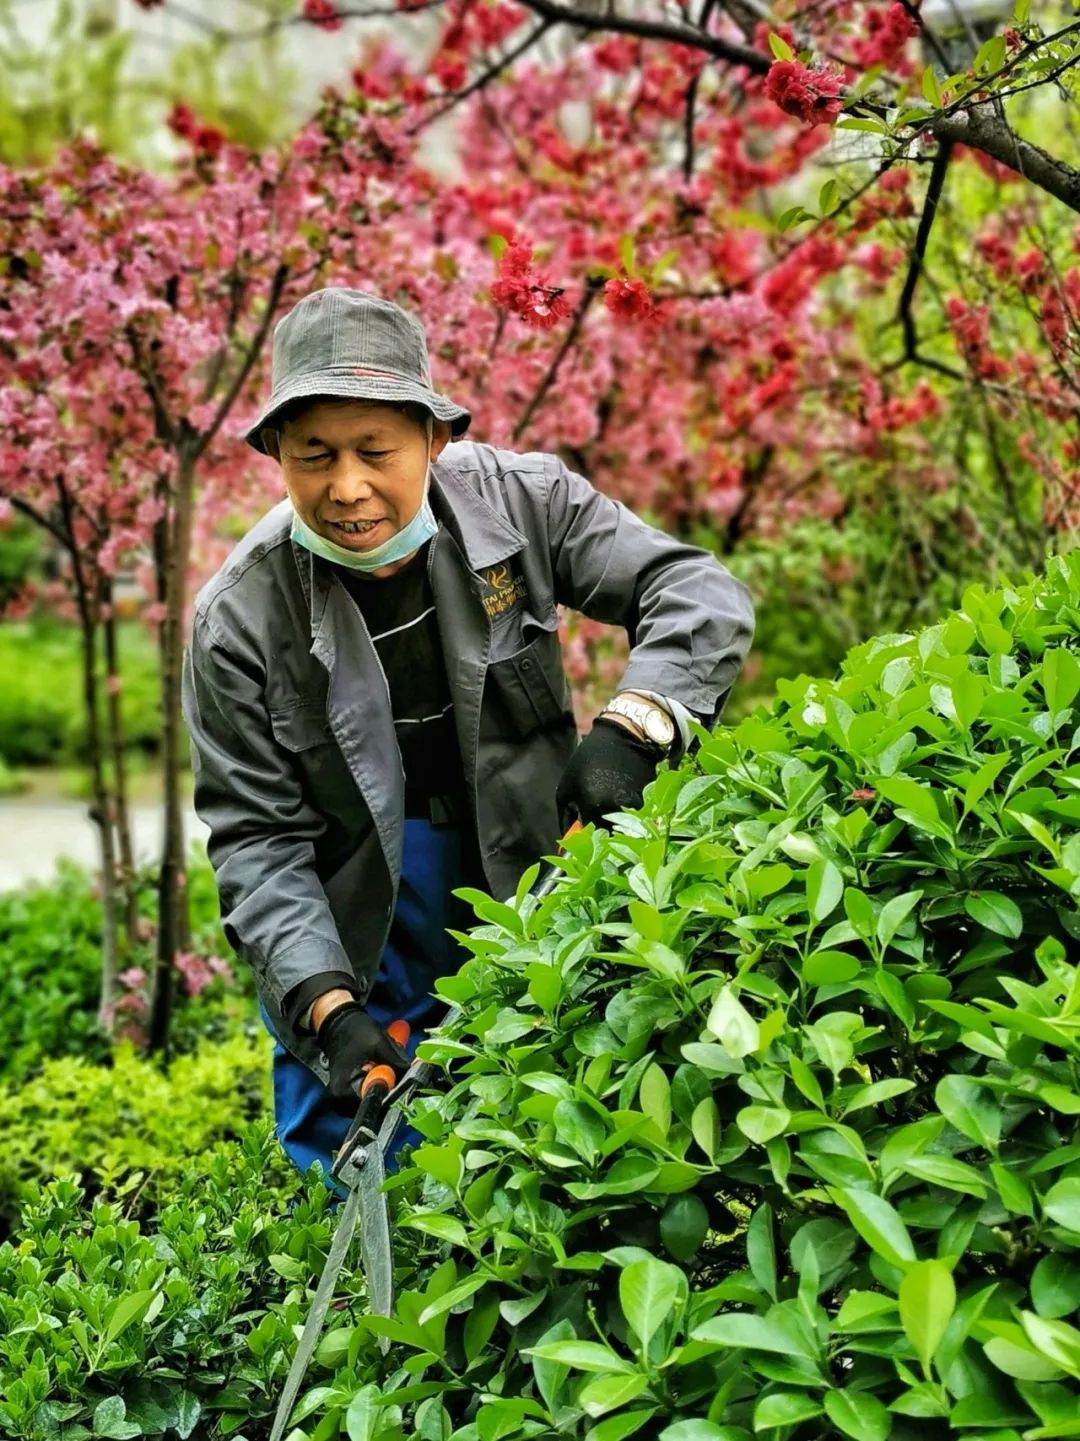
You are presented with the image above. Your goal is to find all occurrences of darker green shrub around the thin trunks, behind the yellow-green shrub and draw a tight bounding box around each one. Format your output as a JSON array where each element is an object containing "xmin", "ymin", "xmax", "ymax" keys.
[{"xmin": 0, "ymin": 853, "xmax": 254, "ymax": 1084}]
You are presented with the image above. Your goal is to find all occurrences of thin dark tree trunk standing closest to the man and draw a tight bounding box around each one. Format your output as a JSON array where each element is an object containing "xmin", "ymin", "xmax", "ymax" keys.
[{"xmin": 150, "ymin": 442, "xmax": 195, "ymax": 1053}]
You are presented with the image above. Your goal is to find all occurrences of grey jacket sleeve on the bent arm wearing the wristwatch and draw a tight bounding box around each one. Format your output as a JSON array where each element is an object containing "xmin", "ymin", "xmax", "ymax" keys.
[{"xmin": 548, "ymin": 457, "xmax": 754, "ymax": 723}]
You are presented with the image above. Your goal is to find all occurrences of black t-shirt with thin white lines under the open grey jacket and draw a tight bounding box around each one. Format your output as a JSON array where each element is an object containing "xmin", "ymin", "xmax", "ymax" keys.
[{"xmin": 339, "ymin": 546, "xmax": 466, "ymax": 820}]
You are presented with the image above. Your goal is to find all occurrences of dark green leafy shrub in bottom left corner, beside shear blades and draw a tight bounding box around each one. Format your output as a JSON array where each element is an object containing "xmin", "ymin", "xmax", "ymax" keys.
[{"xmin": 0, "ymin": 1124, "xmax": 328, "ymax": 1441}]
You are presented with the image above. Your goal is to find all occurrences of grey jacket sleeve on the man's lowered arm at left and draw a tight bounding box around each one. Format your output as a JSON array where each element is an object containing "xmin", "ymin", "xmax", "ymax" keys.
[{"xmin": 183, "ymin": 617, "xmax": 359, "ymax": 1029}]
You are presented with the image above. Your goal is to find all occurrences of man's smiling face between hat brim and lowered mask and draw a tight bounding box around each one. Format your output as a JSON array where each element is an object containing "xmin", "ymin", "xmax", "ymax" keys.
[{"xmin": 278, "ymin": 401, "xmax": 450, "ymax": 575}]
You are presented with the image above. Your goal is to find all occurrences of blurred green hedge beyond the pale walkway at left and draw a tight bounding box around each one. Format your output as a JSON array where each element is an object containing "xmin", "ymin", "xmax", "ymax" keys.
[{"xmin": 0, "ymin": 618, "xmax": 161, "ymax": 765}]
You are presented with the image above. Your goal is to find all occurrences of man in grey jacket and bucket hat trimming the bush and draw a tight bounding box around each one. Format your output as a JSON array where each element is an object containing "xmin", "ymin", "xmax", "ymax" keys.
[{"xmin": 185, "ymin": 288, "xmax": 751, "ymax": 1170}]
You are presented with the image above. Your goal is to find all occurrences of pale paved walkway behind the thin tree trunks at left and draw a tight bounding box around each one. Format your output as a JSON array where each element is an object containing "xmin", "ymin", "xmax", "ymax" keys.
[{"xmin": 0, "ymin": 795, "xmax": 206, "ymax": 891}]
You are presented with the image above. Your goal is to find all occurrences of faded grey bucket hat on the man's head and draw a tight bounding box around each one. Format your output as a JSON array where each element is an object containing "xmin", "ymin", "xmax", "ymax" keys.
[{"xmin": 244, "ymin": 285, "xmax": 472, "ymax": 455}]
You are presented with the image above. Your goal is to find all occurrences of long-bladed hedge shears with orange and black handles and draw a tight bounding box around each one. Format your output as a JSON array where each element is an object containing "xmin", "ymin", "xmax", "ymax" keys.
[{"xmin": 270, "ymin": 821, "xmax": 581, "ymax": 1441}]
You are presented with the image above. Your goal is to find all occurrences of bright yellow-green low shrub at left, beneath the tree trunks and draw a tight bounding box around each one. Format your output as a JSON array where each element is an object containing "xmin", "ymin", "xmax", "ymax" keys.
[{"xmin": 0, "ymin": 1027, "xmax": 270, "ymax": 1219}]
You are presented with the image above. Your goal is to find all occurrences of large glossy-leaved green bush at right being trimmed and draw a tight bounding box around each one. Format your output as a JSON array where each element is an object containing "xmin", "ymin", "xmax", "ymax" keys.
[{"xmin": 296, "ymin": 559, "xmax": 1080, "ymax": 1441}]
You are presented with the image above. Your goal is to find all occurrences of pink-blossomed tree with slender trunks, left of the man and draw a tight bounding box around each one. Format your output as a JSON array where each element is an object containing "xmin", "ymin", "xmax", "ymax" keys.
[{"xmin": 0, "ymin": 131, "xmax": 313, "ymax": 1043}]
